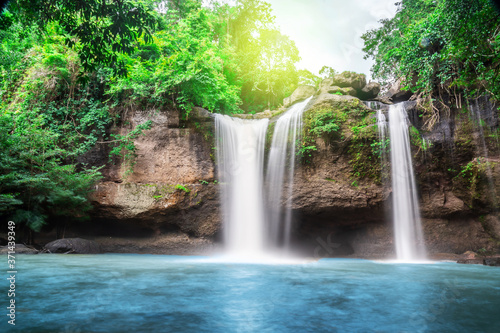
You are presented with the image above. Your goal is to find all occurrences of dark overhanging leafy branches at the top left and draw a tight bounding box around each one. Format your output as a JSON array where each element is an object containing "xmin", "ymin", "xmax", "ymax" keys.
[{"xmin": 11, "ymin": 0, "xmax": 157, "ymax": 74}]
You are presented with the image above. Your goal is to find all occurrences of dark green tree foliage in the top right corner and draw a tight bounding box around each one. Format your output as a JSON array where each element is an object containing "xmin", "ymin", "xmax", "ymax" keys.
[{"xmin": 363, "ymin": 0, "xmax": 500, "ymax": 102}]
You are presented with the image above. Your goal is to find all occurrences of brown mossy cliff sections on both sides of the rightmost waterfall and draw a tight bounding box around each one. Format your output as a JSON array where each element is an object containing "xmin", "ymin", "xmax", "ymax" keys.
[{"xmin": 293, "ymin": 87, "xmax": 500, "ymax": 258}]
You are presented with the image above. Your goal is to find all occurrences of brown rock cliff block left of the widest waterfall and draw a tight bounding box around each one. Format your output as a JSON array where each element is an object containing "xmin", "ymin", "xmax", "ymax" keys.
[{"xmin": 86, "ymin": 107, "xmax": 220, "ymax": 245}]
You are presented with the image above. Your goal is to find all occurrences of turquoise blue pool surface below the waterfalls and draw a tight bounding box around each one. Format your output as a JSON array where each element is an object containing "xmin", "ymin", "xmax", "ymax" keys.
[{"xmin": 0, "ymin": 254, "xmax": 500, "ymax": 332}]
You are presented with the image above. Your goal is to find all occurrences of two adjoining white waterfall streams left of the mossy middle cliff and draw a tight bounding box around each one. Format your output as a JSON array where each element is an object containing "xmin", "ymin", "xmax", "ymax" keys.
[{"xmin": 215, "ymin": 97, "xmax": 312, "ymax": 259}]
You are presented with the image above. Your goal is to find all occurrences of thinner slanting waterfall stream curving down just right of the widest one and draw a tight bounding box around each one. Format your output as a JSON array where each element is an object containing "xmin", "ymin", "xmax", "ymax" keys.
[{"xmin": 266, "ymin": 96, "xmax": 312, "ymax": 250}]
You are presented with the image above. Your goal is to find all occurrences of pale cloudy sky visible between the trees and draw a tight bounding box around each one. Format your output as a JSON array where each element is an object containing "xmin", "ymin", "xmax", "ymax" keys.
[{"xmin": 266, "ymin": 0, "xmax": 397, "ymax": 78}]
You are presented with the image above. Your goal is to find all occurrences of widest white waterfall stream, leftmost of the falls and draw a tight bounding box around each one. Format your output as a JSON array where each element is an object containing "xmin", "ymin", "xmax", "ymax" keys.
[{"xmin": 215, "ymin": 114, "xmax": 269, "ymax": 258}]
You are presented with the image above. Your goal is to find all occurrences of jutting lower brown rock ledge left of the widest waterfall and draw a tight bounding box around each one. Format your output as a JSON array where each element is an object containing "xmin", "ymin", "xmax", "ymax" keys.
[{"xmin": 93, "ymin": 182, "xmax": 220, "ymax": 236}]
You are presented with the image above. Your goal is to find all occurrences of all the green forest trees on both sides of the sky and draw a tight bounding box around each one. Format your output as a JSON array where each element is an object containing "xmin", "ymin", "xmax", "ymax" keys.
[{"xmin": 0, "ymin": 0, "xmax": 500, "ymax": 231}]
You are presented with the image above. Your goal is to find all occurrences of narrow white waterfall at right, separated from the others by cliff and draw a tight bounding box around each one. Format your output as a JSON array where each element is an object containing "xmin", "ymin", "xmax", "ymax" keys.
[{"xmin": 389, "ymin": 103, "xmax": 425, "ymax": 261}]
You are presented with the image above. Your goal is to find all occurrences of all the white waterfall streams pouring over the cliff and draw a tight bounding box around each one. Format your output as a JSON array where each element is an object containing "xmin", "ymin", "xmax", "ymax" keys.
[{"xmin": 215, "ymin": 97, "xmax": 425, "ymax": 261}]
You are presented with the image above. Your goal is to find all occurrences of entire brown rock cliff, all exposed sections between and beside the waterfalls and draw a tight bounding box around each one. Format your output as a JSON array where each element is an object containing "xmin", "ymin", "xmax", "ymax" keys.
[{"xmin": 86, "ymin": 77, "xmax": 500, "ymax": 258}]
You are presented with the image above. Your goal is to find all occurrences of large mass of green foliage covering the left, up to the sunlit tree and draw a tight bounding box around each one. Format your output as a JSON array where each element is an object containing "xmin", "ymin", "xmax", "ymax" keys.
[{"xmin": 0, "ymin": 0, "xmax": 304, "ymax": 230}]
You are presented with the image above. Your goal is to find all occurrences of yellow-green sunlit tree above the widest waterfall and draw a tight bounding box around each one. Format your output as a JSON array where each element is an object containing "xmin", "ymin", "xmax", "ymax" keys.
[{"xmin": 222, "ymin": 0, "xmax": 302, "ymax": 111}]
